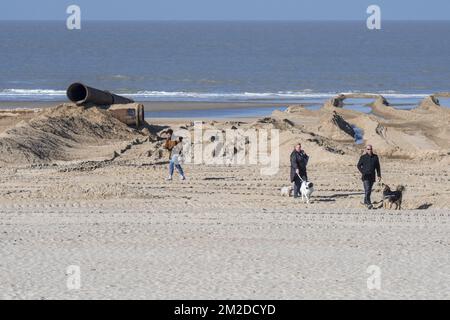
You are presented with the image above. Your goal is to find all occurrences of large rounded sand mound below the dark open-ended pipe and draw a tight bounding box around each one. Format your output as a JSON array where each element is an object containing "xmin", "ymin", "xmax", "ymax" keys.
[{"xmin": 0, "ymin": 104, "xmax": 138, "ymax": 164}]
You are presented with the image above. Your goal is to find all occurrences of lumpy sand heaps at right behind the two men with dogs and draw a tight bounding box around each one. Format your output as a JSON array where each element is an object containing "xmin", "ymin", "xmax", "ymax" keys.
[{"xmin": 272, "ymin": 98, "xmax": 450, "ymax": 160}]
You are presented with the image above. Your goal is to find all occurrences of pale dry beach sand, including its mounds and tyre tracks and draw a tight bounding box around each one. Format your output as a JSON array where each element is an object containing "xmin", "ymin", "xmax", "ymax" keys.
[{"xmin": 0, "ymin": 105, "xmax": 450, "ymax": 299}]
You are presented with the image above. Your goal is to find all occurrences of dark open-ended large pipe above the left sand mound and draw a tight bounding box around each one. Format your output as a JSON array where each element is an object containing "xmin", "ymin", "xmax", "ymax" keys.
[{"xmin": 67, "ymin": 82, "xmax": 134, "ymax": 106}]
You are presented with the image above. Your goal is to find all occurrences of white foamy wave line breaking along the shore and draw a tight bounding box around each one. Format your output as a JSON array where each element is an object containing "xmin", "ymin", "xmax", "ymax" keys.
[{"xmin": 0, "ymin": 89, "xmax": 427, "ymax": 102}]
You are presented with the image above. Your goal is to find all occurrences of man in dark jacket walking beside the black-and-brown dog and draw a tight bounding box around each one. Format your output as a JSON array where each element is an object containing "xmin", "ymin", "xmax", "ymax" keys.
[{"xmin": 358, "ymin": 144, "xmax": 381, "ymax": 209}]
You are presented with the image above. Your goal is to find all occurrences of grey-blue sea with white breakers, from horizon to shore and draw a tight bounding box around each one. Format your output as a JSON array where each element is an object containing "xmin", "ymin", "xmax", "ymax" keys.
[{"xmin": 0, "ymin": 21, "xmax": 450, "ymax": 115}]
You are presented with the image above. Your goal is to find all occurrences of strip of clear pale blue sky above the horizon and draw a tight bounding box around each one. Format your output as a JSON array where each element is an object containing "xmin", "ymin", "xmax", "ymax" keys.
[{"xmin": 0, "ymin": 0, "xmax": 450, "ymax": 20}]
